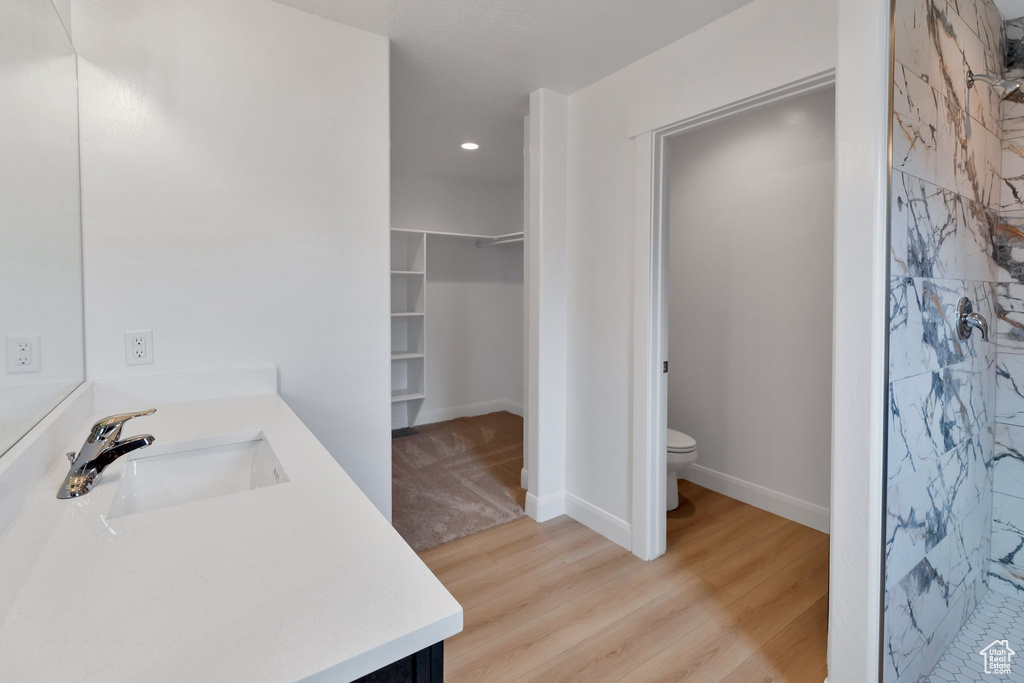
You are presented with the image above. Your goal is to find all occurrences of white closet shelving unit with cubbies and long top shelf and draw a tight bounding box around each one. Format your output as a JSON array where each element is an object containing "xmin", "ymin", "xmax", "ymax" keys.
[{"xmin": 391, "ymin": 227, "xmax": 524, "ymax": 429}]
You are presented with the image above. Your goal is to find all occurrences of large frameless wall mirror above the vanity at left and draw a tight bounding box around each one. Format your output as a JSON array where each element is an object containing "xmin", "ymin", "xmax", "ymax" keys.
[{"xmin": 0, "ymin": 0, "xmax": 85, "ymax": 455}]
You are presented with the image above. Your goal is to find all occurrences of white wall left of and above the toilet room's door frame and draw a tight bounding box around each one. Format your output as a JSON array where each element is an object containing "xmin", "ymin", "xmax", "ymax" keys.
[{"xmin": 566, "ymin": 0, "xmax": 836, "ymax": 520}]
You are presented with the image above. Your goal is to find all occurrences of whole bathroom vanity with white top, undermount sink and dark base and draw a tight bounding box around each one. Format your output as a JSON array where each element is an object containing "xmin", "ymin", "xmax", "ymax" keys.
[{"xmin": 0, "ymin": 369, "xmax": 462, "ymax": 681}]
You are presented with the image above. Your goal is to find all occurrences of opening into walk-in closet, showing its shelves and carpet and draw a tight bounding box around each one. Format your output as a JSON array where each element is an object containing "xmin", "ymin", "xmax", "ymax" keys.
[{"xmin": 391, "ymin": 169, "xmax": 526, "ymax": 552}]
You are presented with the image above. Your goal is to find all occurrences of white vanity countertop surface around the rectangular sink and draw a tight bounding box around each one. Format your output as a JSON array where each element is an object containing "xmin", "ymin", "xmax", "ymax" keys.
[{"xmin": 0, "ymin": 394, "xmax": 462, "ymax": 681}]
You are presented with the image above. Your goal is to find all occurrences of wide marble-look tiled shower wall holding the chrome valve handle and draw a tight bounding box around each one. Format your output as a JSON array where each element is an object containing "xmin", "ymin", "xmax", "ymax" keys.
[{"xmin": 885, "ymin": 0, "xmax": 1006, "ymax": 683}]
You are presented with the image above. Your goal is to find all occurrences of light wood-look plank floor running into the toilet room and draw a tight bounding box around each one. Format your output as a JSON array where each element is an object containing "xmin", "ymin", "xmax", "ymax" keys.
[{"xmin": 420, "ymin": 481, "xmax": 828, "ymax": 683}]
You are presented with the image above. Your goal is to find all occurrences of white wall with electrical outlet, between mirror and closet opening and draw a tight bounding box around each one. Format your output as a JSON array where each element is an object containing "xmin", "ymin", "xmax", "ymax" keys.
[{"xmin": 73, "ymin": 0, "xmax": 391, "ymax": 515}]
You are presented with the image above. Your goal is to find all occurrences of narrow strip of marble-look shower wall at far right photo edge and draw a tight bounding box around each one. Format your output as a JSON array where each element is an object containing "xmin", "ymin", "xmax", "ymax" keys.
[{"xmin": 989, "ymin": 19, "xmax": 1024, "ymax": 597}]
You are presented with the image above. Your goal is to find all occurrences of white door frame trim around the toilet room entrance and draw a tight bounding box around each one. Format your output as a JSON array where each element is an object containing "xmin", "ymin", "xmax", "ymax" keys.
[{"xmin": 632, "ymin": 69, "xmax": 836, "ymax": 559}]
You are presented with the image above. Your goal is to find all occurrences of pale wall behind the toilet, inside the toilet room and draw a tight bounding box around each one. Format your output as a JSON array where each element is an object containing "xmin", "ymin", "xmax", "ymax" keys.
[{"xmin": 669, "ymin": 88, "xmax": 836, "ymax": 530}]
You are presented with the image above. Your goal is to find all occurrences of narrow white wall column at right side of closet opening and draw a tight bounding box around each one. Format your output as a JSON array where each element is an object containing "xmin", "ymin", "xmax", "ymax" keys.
[{"xmin": 525, "ymin": 89, "xmax": 568, "ymax": 521}]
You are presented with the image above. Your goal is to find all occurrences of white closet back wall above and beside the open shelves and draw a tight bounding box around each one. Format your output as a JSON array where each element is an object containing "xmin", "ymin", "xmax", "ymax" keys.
[{"xmin": 391, "ymin": 169, "xmax": 523, "ymax": 424}]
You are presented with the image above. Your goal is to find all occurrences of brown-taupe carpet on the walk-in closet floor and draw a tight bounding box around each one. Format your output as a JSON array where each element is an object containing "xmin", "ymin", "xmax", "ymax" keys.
[{"xmin": 391, "ymin": 411, "xmax": 526, "ymax": 552}]
